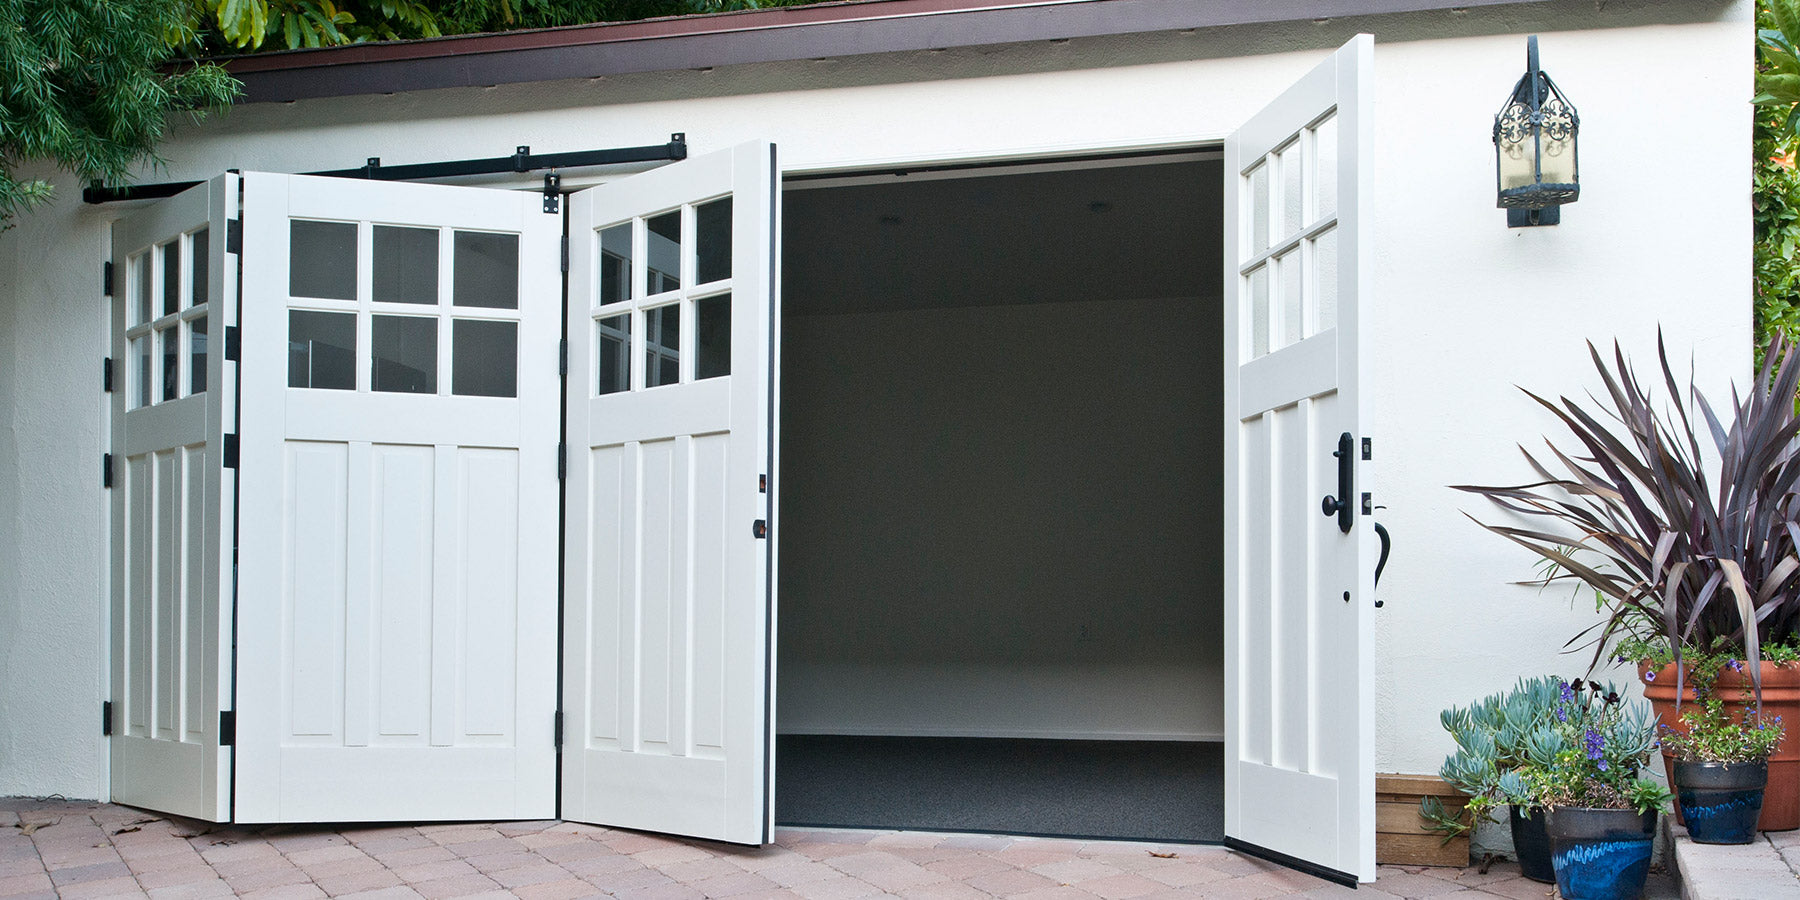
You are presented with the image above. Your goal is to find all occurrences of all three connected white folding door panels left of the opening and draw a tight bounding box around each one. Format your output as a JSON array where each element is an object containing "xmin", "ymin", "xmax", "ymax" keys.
[{"xmin": 112, "ymin": 144, "xmax": 776, "ymax": 842}]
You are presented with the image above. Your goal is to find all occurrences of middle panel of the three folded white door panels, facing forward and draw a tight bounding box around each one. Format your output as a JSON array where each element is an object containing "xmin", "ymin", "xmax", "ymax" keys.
[{"xmin": 236, "ymin": 173, "xmax": 562, "ymax": 823}]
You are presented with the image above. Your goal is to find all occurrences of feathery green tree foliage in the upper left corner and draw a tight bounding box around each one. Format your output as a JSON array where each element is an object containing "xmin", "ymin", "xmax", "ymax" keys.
[{"xmin": 0, "ymin": 0, "xmax": 238, "ymax": 223}]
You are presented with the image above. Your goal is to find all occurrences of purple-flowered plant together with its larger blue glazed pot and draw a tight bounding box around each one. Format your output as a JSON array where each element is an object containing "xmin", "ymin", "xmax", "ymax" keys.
[{"xmin": 1519, "ymin": 680, "xmax": 1670, "ymax": 900}]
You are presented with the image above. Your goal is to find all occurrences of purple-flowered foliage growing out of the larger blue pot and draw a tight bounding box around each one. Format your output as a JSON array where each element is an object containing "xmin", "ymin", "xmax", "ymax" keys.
[{"xmin": 1519, "ymin": 679, "xmax": 1672, "ymax": 814}]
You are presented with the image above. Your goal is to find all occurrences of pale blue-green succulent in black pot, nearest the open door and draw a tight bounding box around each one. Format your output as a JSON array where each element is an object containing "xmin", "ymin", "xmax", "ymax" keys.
[{"xmin": 1418, "ymin": 675, "xmax": 1566, "ymax": 882}]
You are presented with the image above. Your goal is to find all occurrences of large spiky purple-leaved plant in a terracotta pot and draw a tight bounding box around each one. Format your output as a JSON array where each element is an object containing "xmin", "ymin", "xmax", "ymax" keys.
[{"xmin": 1458, "ymin": 338, "xmax": 1800, "ymax": 830}]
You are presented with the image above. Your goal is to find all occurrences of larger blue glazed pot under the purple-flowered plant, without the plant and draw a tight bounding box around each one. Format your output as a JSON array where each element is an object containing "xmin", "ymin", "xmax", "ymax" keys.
[{"xmin": 1544, "ymin": 806, "xmax": 1656, "ymax": 900}]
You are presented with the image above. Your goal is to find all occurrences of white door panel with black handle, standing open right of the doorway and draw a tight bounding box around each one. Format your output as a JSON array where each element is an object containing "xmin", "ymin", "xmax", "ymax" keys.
[{"xmin": 1224, "ymin": 34, "xmax": 1375, "ymax": 880}]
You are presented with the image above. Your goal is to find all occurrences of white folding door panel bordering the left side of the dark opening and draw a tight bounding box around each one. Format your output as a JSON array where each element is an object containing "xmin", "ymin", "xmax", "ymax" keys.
[{"xmin": 563, "ymin": 144, "xmax": 778, "ymax": 844}]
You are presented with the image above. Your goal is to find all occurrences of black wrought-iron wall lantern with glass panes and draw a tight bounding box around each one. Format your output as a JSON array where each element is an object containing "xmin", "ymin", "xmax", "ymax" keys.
[{"xmin": 1494, "ymin": 34, "xmax": 1580, "ymax": 229}]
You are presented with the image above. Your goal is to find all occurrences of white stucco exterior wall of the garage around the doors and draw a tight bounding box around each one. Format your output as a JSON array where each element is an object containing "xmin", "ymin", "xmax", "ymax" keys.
[{"xmin": 0, "ymin": 0, "xmax": 1751, "ymax": 797}]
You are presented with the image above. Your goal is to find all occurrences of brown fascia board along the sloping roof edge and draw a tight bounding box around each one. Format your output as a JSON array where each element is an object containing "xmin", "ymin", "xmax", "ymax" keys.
[{"xmin": 225, "ymin": 0, "xmax": 1537, "ymax": 103}]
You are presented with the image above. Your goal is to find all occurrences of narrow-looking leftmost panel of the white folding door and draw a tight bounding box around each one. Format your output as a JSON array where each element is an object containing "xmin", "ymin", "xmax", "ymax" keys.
[{"xmin": 104, "ymin": 176, "xmax": 238, "ymax": 821}]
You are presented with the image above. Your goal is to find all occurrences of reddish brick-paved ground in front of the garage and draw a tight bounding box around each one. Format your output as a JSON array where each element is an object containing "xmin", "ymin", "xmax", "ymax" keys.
[{"xmin": 0, "ymin": 799, "xmax": 1674, "ymax": 900}]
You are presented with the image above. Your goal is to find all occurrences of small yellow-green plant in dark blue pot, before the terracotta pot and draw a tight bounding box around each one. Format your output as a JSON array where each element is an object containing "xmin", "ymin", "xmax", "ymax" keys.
[{"xmin": 1661, "ymin": 661, "xmax": 1782, "ymax": 844}]
